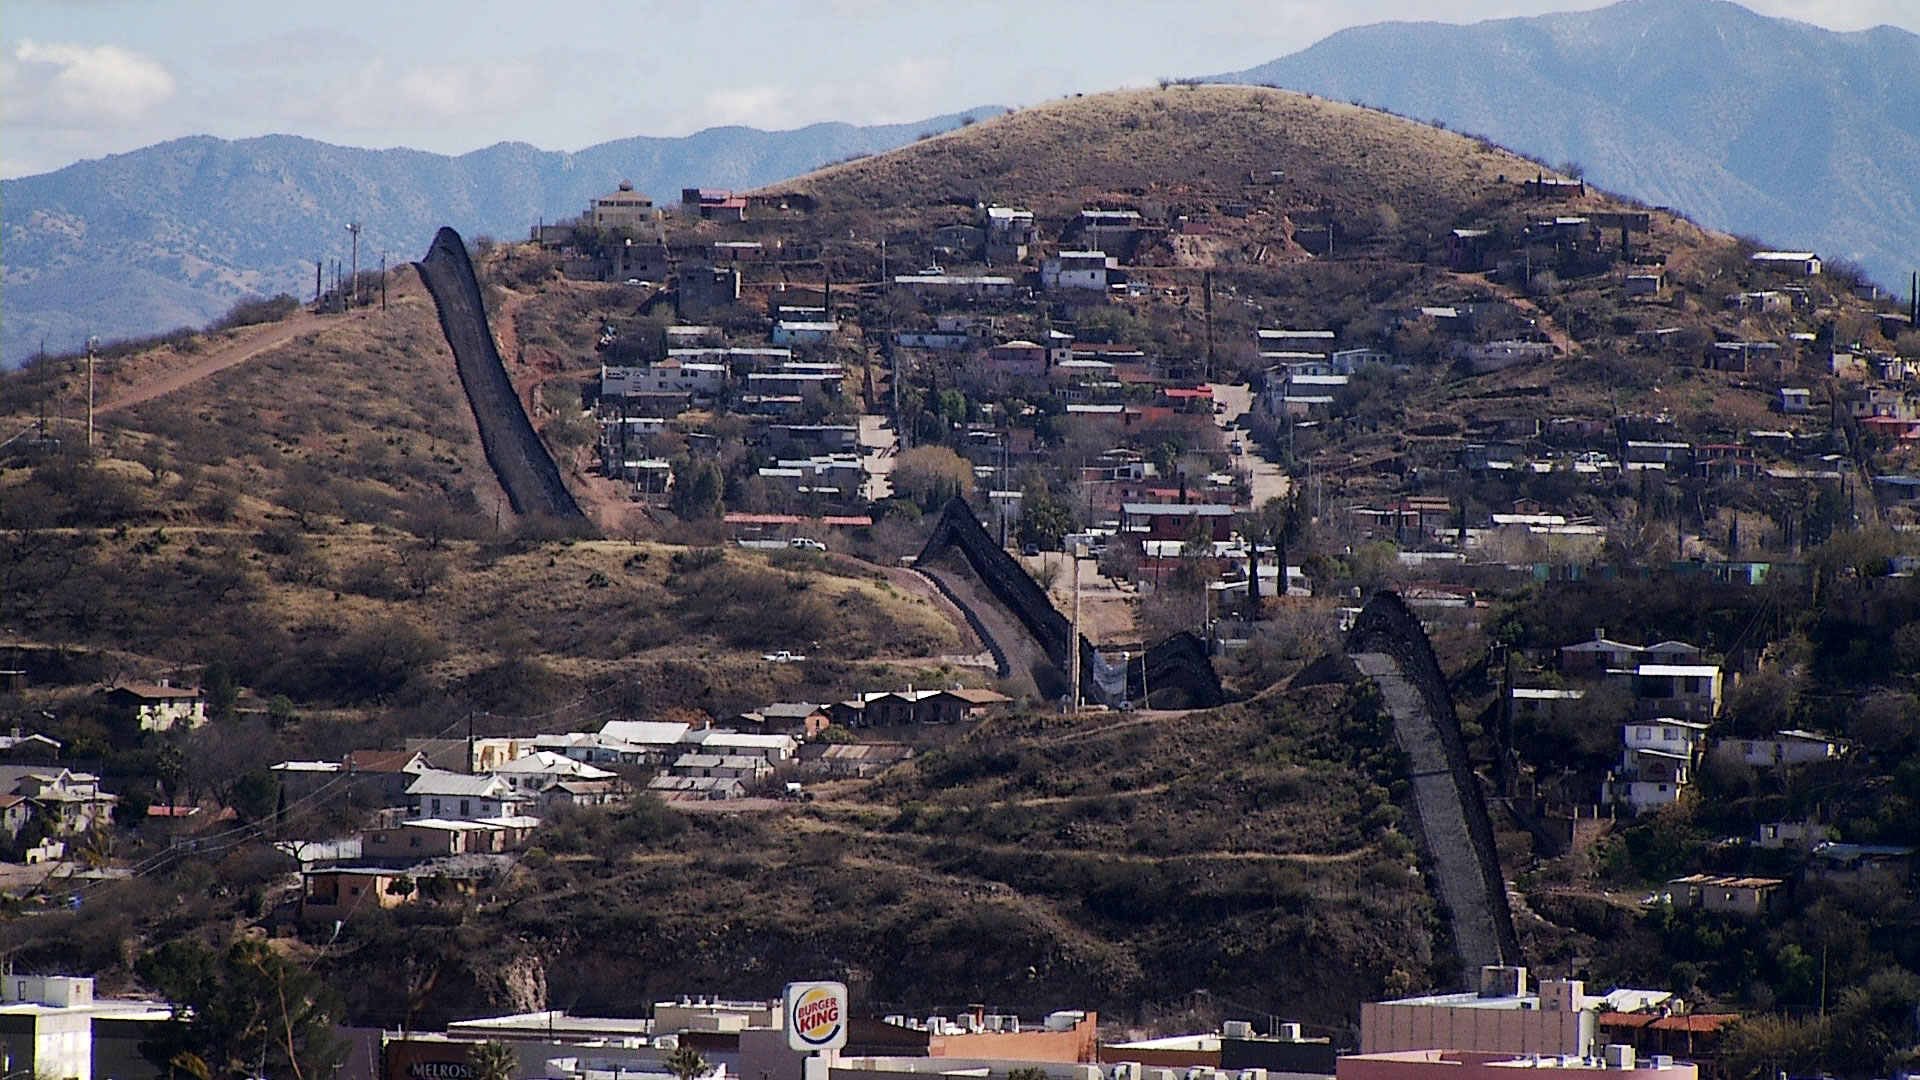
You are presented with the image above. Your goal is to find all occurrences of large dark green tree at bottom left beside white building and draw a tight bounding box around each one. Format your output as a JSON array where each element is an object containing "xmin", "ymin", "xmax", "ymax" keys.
[{"xmin": 134, "ymin": 938, "xmax": 346, "ymax": 1080}]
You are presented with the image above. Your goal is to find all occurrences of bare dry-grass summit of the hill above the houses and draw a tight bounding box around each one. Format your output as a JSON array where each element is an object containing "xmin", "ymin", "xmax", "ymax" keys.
[{"xmin": 770, "ymin": 86, "xmax": 1538, "ymax": 233}]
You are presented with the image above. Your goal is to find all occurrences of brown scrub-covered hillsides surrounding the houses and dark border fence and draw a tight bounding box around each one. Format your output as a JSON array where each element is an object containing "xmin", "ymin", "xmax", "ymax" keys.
[{"xmin": 0, "ymin": 86, "xmax": 1920, "ymax": 1042}]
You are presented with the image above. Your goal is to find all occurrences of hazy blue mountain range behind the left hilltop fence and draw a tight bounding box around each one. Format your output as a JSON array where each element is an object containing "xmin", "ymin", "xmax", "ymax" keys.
[{"xmin": 0, "ymin": 106, "xmax": 1002, "ymax": 367}]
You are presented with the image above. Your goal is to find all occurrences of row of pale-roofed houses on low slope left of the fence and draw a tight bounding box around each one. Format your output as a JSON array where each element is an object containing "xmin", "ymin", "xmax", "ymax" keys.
[{"xmin": 273, "ymin": 688, "xmax": 1012, "ymax": 922}]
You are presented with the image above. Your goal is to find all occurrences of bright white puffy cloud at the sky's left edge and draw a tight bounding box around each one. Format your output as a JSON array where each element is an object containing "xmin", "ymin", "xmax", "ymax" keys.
[{"xmin": 0, "ymin": 38, "xmax": 179, "ymax": 131}]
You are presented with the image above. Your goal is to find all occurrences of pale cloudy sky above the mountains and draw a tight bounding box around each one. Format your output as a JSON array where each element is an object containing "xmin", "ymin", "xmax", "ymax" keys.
[{"xmin": 0, "ymin": 0, "xmax": 1920, "ymax": 179}]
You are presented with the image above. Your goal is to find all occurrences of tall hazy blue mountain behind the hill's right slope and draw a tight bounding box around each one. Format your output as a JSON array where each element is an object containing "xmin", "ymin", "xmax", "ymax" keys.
[{"xmin": 1215, "ymin": 0, "xmax": 1920, "ymax": 292}]
